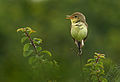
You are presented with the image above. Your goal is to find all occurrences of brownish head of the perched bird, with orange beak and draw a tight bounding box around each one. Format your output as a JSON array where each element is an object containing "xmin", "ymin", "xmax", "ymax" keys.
[{"xmin": 66, "ymin": 12, "xmax": 86, "ymax": 23}]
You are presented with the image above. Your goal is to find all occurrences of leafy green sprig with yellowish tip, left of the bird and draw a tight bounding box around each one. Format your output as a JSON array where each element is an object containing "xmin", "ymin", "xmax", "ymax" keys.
[{"xmin": 17, "ymin": 27, "xmax": 57, "ymax": 68}]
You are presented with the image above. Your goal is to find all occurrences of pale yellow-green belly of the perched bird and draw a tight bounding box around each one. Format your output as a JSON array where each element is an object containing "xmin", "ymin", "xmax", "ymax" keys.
[{"xmin": 71, "ymin": 26, "xmax": 87, "ymax": 42}]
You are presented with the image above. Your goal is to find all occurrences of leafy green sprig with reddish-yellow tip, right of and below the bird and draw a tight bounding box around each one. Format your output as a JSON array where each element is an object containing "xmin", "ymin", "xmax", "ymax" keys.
[{"xmin": 85, "ymin": 53, "xmax": 108, "ymax": 82}]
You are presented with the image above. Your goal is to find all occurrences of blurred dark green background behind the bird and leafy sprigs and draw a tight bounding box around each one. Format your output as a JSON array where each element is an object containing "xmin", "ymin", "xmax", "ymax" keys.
[{"xmin": 0, "ymin": 0, "xmax": 120, "ymax": 82}]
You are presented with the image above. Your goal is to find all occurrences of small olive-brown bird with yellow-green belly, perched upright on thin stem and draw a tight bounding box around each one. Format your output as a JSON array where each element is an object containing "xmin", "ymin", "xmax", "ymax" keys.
[{"xmin": 66, "ymin": 12, "xmax": 88, "ymax": 55}]
